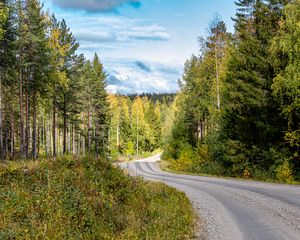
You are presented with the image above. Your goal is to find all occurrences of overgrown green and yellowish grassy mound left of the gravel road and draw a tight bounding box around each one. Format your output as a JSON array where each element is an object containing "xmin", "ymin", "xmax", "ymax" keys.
[{"xmin": 0, "ymin": 157, "xmax": 195, "ymax": 240}]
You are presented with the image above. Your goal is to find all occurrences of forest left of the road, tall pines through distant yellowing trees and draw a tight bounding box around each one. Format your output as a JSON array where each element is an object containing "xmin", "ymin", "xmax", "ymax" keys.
[{"xmin": 0, "ymin": 1, "xmax": 174, "ymax": 162}]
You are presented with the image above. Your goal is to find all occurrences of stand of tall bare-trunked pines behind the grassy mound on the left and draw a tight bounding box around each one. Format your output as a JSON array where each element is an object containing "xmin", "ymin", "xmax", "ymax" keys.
[{"xmin": 0, "ymin": 0, "xmax": 110, "ymax": 159}]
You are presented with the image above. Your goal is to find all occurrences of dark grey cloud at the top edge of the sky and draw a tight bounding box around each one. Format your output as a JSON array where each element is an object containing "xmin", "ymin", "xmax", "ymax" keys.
[{"xmin": 52, "ymin": 0, "xmax": 141, "ymax": 12}]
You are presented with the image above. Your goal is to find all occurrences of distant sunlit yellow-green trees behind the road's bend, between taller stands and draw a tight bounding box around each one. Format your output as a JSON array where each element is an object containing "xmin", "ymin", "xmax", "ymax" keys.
[{"xmin": 109, "ymin": 94, "xmax": 172, "ymax": 159}]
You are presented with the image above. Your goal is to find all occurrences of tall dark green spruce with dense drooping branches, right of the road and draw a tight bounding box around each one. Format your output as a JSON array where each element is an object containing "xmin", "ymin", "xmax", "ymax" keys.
[{"xmin": 221, "ymin": 0, "xmax": 283, "ymax": 171}]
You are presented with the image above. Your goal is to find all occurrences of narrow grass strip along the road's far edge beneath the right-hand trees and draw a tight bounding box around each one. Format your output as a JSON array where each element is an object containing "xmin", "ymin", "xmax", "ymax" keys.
[{"xmin": 159, "ymin": 160, "xmax": 300, "ymax": 185}]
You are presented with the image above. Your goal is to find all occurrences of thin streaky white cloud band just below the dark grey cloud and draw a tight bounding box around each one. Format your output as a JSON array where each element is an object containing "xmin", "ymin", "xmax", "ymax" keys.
[{"xmin": 61, "ymin": 14, "xmax": 171, "ymax": 45}]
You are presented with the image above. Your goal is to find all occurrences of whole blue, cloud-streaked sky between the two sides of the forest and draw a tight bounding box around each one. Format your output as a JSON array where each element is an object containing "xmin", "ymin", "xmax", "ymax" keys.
[{"xmin": 44, "ymin": 0, "xmax": 235, "ymax": 94}]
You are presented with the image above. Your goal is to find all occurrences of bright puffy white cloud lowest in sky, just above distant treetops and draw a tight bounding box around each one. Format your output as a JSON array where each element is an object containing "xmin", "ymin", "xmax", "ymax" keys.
[{"xmin": 104, "ymin": 59, "xmax": 182, "ymax": 94}]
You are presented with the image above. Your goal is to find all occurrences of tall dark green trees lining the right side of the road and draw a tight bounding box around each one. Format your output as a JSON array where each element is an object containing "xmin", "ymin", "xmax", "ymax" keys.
[{"xmin": 164, "ymin": 0, "xmax": 300, "ymax": 182}]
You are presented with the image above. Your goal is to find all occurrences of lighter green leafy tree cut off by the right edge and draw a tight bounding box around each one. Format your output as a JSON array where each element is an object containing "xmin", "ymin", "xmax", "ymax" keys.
[{"xmin": 272, "ymin": 0, "xmax": 300, "ymax": 172}]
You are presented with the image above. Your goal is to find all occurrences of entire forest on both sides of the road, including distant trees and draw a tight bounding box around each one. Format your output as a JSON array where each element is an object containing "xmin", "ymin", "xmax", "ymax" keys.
[{"xmin": 0, "ymin": 0, "xmax": 300, "ymax": 182}]
